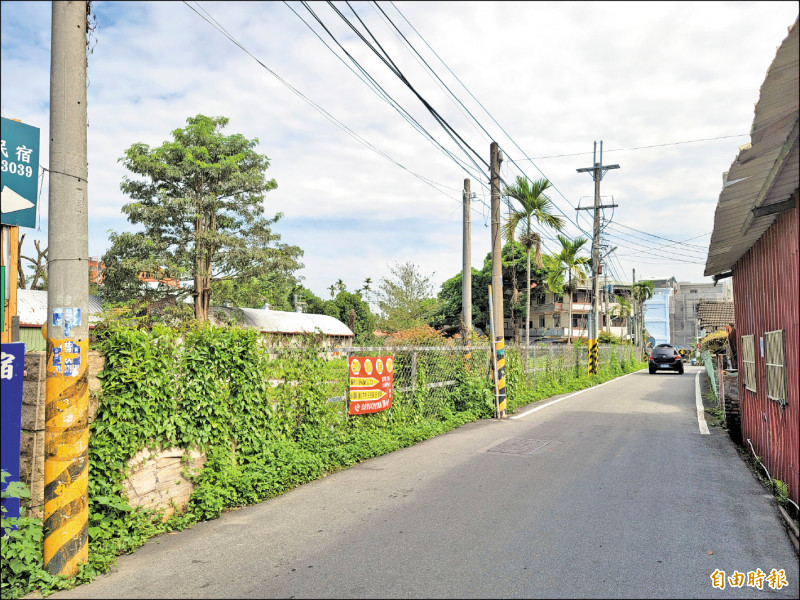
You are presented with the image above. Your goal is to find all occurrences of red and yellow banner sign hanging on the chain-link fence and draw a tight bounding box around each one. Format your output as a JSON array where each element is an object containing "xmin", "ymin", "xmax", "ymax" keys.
[{"xmin": 347, "ymin": 356, "xmax": 394, "ymax": 415}]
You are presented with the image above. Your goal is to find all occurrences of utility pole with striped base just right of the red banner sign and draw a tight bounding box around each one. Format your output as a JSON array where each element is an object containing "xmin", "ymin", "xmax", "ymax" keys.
[{"xmin": 489, "ymin": 142, "xmax": 506, "ymax": 418}]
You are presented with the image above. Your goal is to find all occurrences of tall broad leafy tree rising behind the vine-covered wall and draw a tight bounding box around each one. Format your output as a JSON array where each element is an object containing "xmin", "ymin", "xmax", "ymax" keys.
[{"xmin": 103, "ymin": 115, "xmax": 303, "ymax": 321}]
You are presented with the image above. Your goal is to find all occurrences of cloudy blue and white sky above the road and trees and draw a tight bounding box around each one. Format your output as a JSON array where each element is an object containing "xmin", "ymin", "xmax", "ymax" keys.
[{"xmin": 0, "ymin": 1, "xmax": 798, "ymax": 297}]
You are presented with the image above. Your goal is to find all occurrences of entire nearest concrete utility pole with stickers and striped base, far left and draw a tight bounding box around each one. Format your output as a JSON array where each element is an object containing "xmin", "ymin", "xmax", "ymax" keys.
[{"xmin": 44, "ymin": 1, "xmax": 89, "ymax": 576}]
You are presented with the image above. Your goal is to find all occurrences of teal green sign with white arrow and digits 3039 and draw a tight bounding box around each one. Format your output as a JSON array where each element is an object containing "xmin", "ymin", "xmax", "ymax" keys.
[{"xmin": 0, "ymin": 118, "xmax": 39, "ymax": 227}]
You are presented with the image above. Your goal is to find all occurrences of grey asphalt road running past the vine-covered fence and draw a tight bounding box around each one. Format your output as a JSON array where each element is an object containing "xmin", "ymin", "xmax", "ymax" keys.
[{"xmin": 52, "ymin": 367, "xmax": 798, "ymax": 598}]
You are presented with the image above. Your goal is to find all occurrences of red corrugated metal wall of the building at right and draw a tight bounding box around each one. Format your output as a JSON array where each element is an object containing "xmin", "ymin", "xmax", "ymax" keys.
[{"xmin": 733, "ymin": 198, "xmax": 800, "ymax": 503}]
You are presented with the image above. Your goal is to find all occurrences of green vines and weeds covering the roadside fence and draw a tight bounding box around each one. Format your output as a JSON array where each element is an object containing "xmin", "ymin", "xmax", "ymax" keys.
[{"xmin": 2, "ymin": 322, "xmax": 645, "ymax": 598}]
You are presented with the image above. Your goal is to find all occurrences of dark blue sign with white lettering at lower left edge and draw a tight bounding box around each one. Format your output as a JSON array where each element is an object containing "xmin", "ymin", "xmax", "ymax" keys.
[{"xmin": 0, "ymin": 343, "xmax": 25, "ymax": 517}]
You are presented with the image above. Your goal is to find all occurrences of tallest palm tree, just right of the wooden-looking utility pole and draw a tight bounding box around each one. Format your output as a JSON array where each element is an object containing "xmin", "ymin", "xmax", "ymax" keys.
[{"xmin": 503, "ymin": 176, "xmax": 564, "ymax": 346}]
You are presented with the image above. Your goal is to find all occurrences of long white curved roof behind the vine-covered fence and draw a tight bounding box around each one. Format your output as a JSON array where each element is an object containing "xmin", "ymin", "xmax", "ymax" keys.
[{"xmin": 210, "ymin": 306, "xmax": 353, "ymax": 337}]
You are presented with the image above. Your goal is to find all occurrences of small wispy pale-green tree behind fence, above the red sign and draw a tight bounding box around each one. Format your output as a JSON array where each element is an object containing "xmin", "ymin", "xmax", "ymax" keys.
[{"xmin": 376, "ymin": 262, "xmax": 437, "ymax": 331}]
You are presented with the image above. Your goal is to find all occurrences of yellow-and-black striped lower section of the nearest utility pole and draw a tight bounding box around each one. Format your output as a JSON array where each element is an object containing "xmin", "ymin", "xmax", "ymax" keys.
[{"xmin": 43, "ymin": 339, "xmax": 89, "ymax": 576}]
